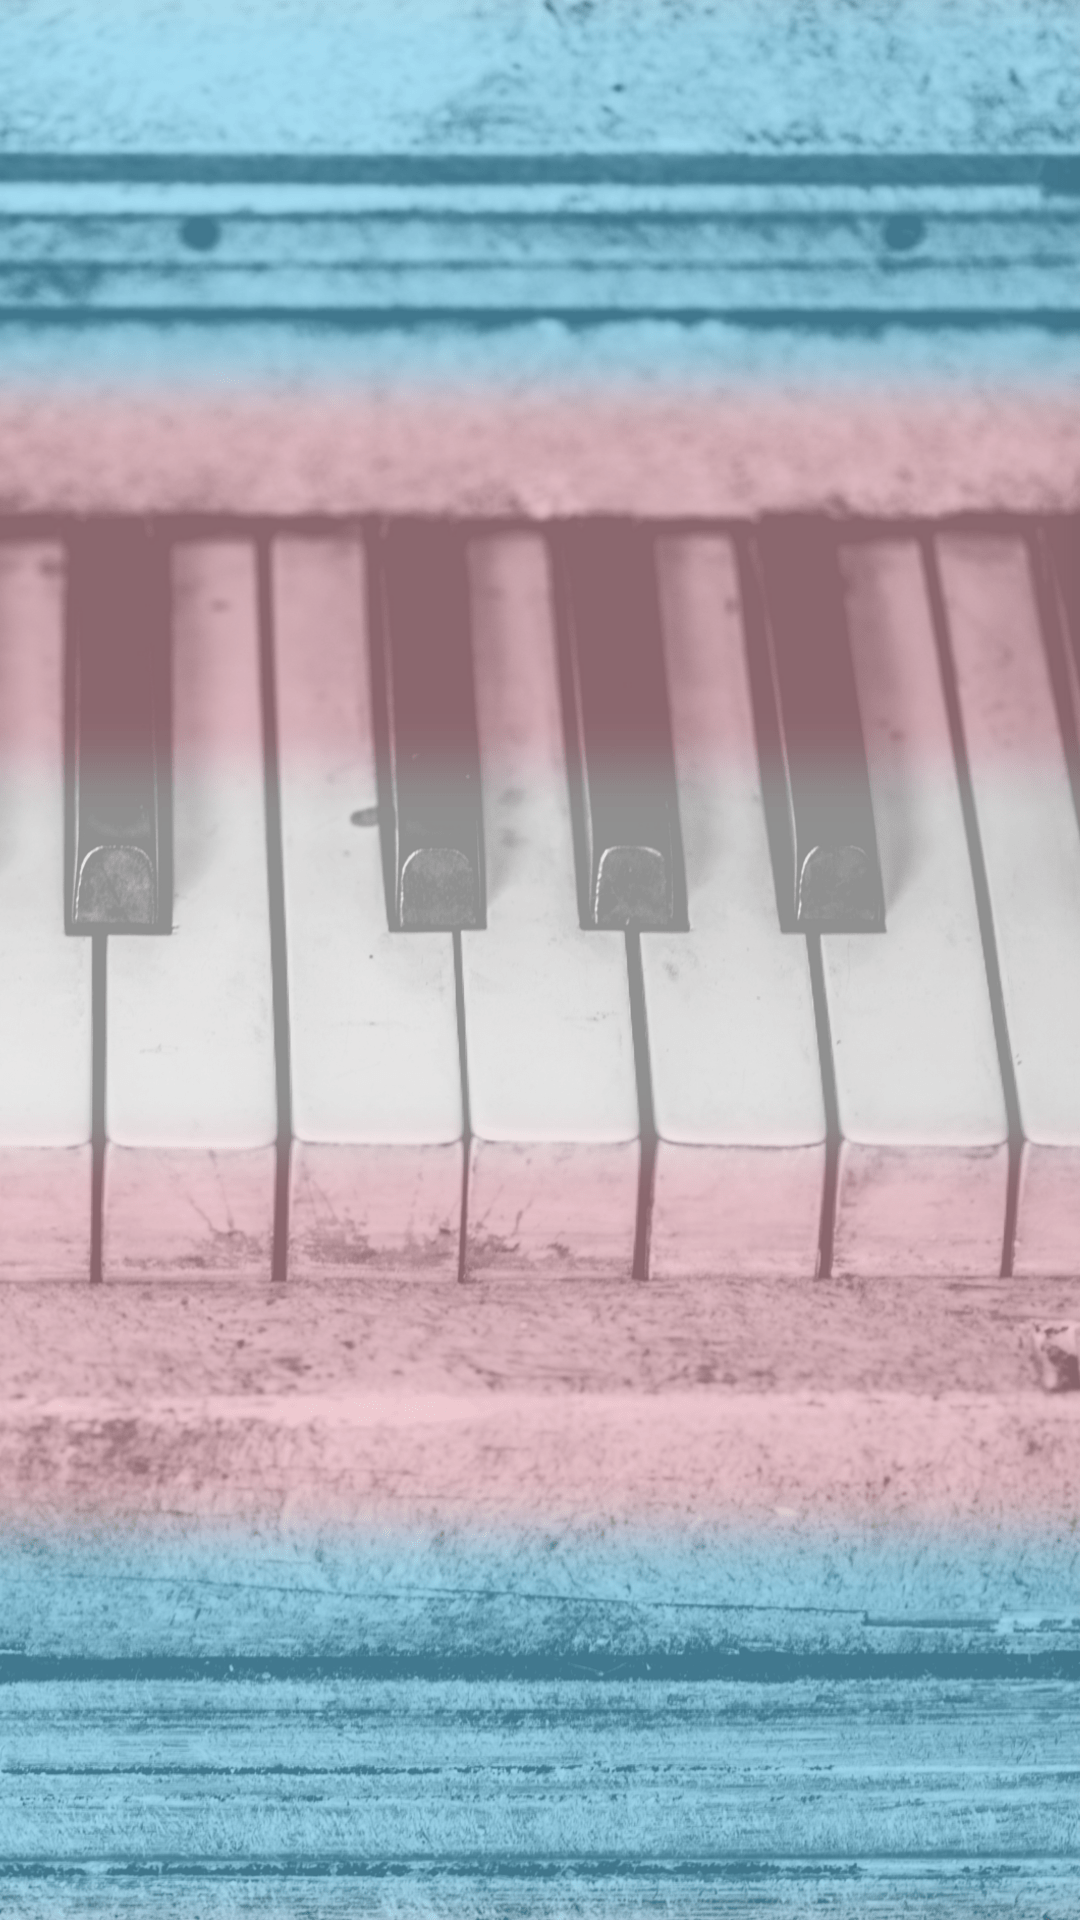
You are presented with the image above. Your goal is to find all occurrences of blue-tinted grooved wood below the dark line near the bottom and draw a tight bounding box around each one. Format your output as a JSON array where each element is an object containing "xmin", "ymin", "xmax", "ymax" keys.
[{"xmin": 0, "ymin": 1676, "xmax": 1080, "ymax": 1916}]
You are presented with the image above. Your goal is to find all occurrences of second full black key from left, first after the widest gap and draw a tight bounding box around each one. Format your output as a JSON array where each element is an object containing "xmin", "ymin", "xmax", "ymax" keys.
[{"xmin": 371, "ymin": 520, "xmax": 484, "ymax": 933}]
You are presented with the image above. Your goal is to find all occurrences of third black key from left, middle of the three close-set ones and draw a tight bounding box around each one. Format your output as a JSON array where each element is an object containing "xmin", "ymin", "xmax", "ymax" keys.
[{"xmin": 555, "ymin": 520, "xmax": 684, "ymax": 927}]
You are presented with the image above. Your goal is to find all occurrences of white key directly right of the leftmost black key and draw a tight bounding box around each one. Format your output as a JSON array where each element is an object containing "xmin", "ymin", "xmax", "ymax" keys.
[{"xmin": 104, "ymin": 543, "xmax": 277, "ymax": 1279}]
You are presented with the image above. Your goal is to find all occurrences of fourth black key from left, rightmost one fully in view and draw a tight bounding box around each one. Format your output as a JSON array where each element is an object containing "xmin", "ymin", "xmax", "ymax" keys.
[{"xmin": 748, "ymin": 516, "xmax": 884, "ymax": 933}]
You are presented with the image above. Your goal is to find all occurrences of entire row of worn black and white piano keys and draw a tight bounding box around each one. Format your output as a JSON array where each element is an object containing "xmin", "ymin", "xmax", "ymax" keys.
[{"xmin": 0, "ymin": 522, "xmax": 1080, "ymax": 1281}]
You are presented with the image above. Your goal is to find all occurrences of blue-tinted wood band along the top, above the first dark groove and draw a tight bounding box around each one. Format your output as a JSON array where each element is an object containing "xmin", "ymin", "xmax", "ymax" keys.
[{"xmin": 0, "ymin": 0, "xmax": 1080, "ymax": 154}]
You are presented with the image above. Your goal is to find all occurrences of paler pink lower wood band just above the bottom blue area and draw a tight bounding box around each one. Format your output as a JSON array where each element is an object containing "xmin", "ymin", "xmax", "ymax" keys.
[{"xmin": 8, "ymin": 1392, "xmax": 1080, "ymax": 1530}]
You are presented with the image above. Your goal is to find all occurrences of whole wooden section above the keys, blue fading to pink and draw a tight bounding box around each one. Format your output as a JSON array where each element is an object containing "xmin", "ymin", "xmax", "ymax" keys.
[{"xmin": 0, "ymin": 11, "xmax": 1080, "ymax": 516}]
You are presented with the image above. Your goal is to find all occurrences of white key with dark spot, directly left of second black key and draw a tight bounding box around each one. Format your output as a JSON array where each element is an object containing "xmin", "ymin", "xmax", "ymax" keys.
[{"xmin": 273, "ymin": 540, "xmax": 465, "ymax": 1279}]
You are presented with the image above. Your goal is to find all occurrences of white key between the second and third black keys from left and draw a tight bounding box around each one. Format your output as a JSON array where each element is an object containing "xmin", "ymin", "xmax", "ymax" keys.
[{"xmin": 461, "ymin": 536, "xmax": 640, "ymax": 1275}]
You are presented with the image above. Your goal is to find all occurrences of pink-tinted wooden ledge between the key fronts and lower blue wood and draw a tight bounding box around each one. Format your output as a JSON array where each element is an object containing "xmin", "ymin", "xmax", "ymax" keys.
[{"xmin": 8, "ymin": 1281, "xmax": 1080, "ymax": 1559}]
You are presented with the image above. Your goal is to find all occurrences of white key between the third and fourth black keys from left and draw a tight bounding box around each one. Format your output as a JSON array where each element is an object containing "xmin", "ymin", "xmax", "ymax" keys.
[{"xmin": 642, "ymin": 536, "xmax": 826, "ymax": 1279}]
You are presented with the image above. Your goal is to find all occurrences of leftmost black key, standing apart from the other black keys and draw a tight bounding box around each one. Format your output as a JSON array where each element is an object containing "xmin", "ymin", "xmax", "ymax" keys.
[{"xmin": 65, "ymin": 522, "xmax": 173, "ymax": 933}]
